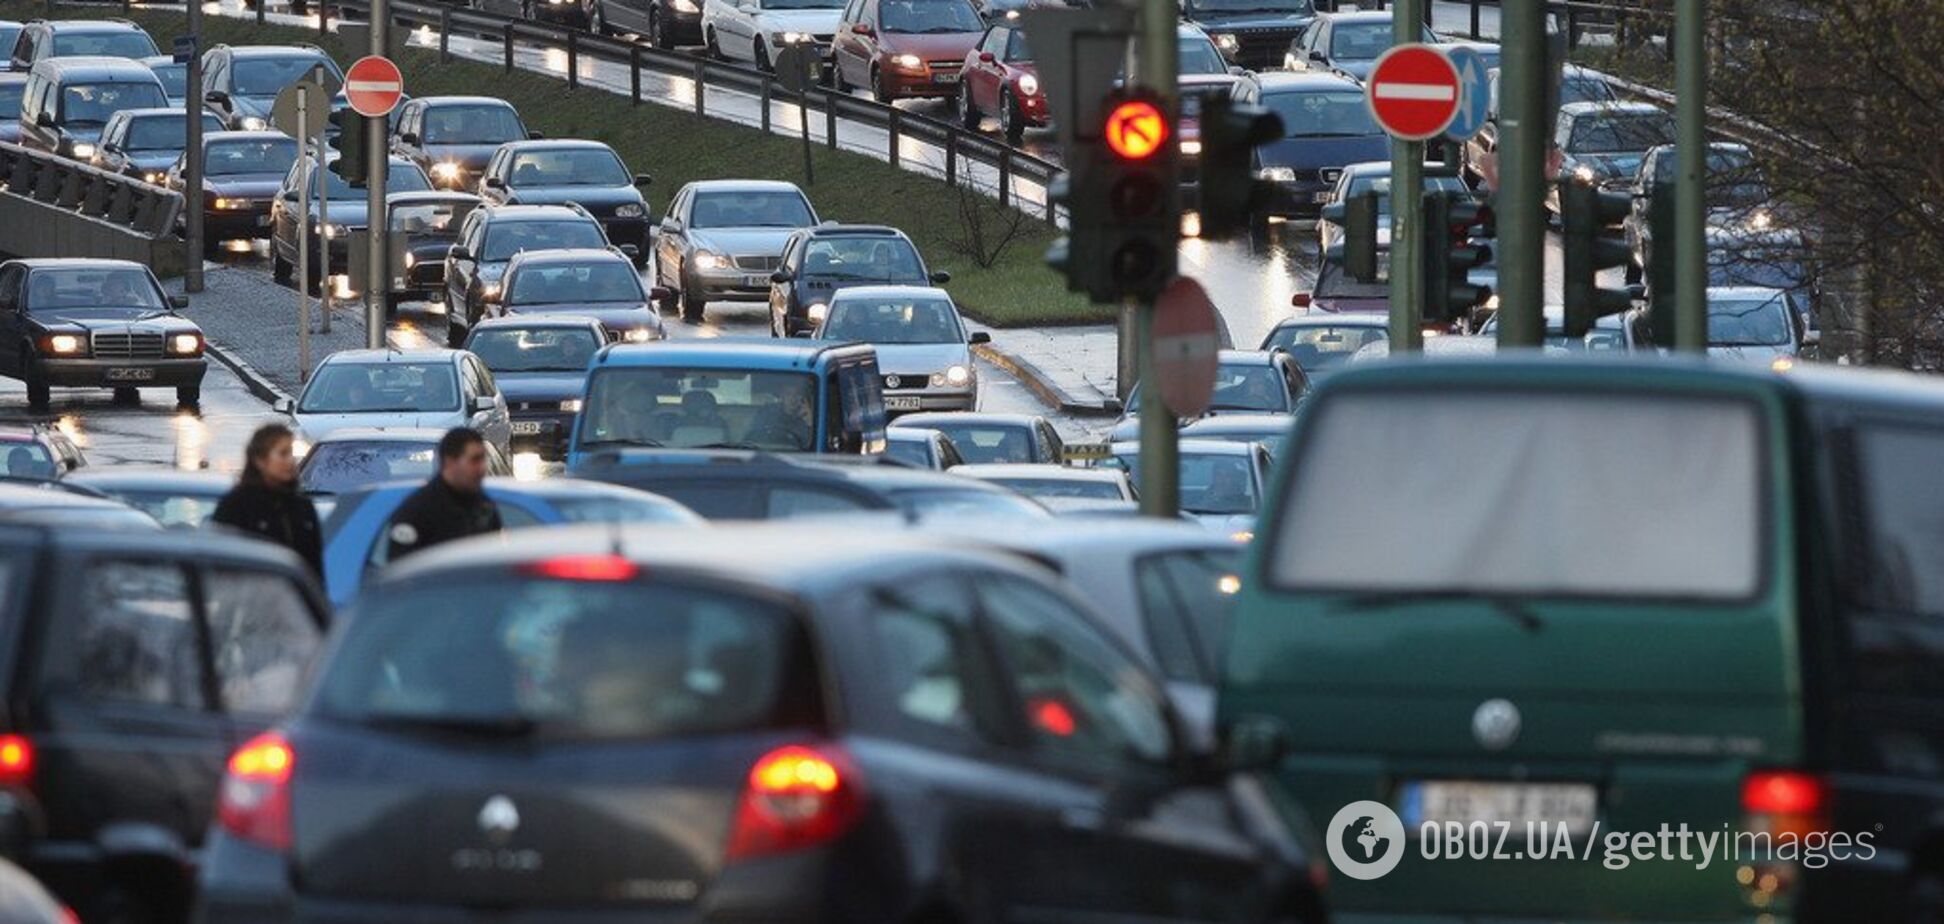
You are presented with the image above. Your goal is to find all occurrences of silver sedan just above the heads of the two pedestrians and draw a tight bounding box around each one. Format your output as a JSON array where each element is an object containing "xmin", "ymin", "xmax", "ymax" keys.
[{"xmin": 278, "ymin": 350, "xmax": 513, "ymax": 455}]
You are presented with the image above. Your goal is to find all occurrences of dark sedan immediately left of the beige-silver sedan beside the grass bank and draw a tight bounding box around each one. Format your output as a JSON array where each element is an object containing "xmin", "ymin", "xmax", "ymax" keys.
[{"xmin": 478, "ymin": 140, "xmax": 653, "ymax": 268}]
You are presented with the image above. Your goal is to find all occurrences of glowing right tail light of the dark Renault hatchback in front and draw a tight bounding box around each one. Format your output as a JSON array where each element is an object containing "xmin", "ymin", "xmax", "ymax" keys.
[{"xmin": 727, "ymin": 745, "xmax": 863, "ymax": 862}]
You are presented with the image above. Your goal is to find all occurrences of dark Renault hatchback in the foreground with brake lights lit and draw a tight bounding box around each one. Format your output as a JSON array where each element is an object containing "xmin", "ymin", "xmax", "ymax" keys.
[{"xmin": 200, "ymin": 527, "xmax": 1320, "ymax": 924}]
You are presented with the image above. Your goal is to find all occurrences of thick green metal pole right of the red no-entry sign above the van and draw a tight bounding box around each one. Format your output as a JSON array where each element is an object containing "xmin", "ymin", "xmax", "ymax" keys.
[{"xmin": 1493, "ymin": 0, "xmax": 1553, "ymax": 348}]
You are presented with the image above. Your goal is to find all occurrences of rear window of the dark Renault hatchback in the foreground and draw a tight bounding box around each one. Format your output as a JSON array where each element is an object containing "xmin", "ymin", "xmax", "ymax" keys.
[{"xmin": 313, "ymin": 572, "xmax": 822, "ymax": 739}]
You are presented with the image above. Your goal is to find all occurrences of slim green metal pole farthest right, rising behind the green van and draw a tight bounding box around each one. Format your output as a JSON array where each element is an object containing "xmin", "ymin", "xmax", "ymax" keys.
[{"xmin": 1674, "ymin": 0, "xmax": 1707, "ymax": 354}]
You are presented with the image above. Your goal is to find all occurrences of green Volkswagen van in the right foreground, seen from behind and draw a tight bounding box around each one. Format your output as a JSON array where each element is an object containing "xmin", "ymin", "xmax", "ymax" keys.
[{"xmin": 1219, "ymin": 356, "xmax": 1944, "ymax": 922}]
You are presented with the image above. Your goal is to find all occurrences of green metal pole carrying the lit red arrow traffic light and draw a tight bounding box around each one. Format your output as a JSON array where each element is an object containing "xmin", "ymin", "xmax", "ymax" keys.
[{"xmin": 1128, "ymin": 0, "xmax": 1182, "ymax": 519}]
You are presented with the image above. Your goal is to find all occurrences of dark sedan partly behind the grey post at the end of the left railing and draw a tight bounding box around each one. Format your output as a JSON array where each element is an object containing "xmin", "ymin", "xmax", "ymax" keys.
[{"xmin": 161, "ymin": 132, "xmax": 297, "ymax": 247}]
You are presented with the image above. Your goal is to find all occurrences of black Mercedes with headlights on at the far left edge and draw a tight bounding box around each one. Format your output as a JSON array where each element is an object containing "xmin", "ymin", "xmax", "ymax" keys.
[{"xmin": 0, "ymin": 259, "xmax": 208, "ymax": 409}]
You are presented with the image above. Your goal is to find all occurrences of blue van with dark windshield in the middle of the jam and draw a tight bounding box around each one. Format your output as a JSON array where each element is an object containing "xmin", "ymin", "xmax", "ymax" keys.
[{"xmin": 568, "ymin": 337, "xmax": 885, "ymax": 471}]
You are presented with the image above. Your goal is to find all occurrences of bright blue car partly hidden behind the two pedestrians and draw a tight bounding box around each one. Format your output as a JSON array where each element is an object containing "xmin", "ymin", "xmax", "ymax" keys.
[{"xmin": 325, "ymin": 479, "xmax": 702, "ymax": 607}]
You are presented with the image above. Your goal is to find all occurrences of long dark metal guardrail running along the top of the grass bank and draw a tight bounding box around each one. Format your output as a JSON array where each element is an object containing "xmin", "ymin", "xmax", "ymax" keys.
[{"xmin": 332, "ymin": 0, "xmax": 1063, "ymax": 222}]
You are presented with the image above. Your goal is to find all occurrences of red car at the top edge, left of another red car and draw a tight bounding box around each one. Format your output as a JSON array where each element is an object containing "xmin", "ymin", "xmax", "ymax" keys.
[{"xmin": 832, "ymin": 0, "xmax": 986, "ymax": 103}]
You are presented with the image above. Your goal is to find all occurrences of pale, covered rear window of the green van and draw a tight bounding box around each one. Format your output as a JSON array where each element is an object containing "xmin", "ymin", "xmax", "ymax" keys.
[{"xmin": 1266, "ymin": 389, "xmax": 1767, "ymax": 599}]
